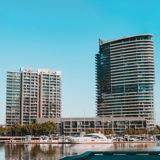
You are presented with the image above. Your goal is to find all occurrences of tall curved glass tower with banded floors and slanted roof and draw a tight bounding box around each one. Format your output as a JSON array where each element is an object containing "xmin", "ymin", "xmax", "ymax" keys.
[{"xmin": 96, "ymin": 34, "xmax": 154, "ymax": 128}]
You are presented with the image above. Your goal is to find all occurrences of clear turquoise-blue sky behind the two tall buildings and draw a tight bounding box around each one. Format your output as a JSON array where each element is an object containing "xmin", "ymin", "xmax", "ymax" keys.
[{"xmin": 0, "ymin": 0, "xmax": 160, "ymax": 124}]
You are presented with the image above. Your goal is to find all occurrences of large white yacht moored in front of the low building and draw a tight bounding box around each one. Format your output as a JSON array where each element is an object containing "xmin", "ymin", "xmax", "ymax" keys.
[{"xmin": 68, "ymin": 133, "xmax": 113, "ymax": 144}]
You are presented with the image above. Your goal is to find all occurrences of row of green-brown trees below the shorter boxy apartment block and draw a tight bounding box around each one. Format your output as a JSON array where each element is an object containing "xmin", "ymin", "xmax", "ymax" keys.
[{"xmin": 0, "ymin": 122, "xmax": 58, "ymax": 136}]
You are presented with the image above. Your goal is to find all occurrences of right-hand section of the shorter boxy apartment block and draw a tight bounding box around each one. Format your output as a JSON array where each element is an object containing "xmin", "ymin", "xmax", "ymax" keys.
[{"xmin": 39, "ymin": 70, "xmax": 61, "ymax": 118}]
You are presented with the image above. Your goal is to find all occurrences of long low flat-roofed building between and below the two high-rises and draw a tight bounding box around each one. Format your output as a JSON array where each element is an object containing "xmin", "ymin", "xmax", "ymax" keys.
[{"xmin": 37, "ymin": 117, "xmax": 146, "ymax": 135}]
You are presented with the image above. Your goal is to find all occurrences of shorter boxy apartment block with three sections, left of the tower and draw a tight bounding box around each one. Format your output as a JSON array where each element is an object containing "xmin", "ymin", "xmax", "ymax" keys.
[{"xmin": 6, "ymin": 68, "xmax": 61, "ymax": 126}]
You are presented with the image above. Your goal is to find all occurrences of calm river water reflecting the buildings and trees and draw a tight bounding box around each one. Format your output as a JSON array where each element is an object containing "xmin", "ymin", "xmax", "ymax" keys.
[{"xmin": 0, "ymin": 143, "xmax": 160, "ymax": 160}]
